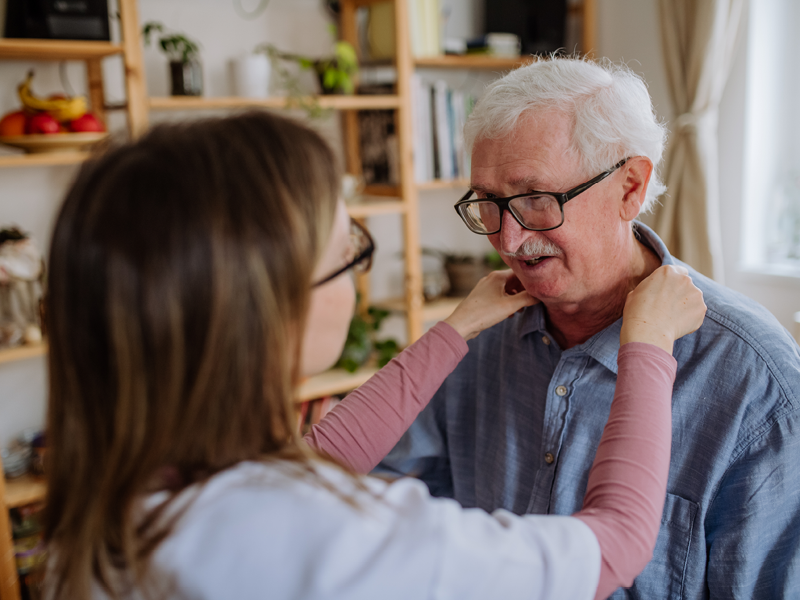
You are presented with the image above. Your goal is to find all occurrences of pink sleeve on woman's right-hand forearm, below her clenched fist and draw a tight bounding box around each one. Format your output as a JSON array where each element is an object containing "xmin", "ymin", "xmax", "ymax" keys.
[{"xmin": 575, "ymin": 343, "xmax": 677, "ymax": 599}]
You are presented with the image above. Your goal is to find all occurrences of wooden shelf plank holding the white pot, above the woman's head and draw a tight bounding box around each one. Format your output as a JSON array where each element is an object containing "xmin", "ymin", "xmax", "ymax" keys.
[{"xmin": 150, "ymin": 95, "xmax": 400, "ymax": 110}]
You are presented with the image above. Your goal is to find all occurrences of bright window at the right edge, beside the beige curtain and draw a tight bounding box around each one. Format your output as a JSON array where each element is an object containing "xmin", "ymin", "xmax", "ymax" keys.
[{"xmin": 742, "ymin": 0, "xmax": 800, "ymax": 276}]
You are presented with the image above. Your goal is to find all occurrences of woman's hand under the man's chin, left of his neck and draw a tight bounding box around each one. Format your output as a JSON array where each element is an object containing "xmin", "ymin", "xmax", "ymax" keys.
[{"xmin": 444, "ymin": 271, "xmax": 538, "ymax": 340}]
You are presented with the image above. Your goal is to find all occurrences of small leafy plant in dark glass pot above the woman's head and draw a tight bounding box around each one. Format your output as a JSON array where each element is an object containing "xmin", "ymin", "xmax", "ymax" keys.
[{"xmin": 142, "ymin": 21, "xmax": 203, "ymax": 96}]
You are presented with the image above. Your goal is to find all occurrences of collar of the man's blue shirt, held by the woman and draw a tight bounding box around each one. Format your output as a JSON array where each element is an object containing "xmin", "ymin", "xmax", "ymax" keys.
[{"xmin": 518, "ymin": 221, "xmax": 676, "ymax": 375}]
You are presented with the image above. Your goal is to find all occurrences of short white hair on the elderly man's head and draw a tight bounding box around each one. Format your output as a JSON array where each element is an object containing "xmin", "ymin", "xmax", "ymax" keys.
[{"xmin": 464, "ymin": 58, "xmax": 667, "ymax": 212}]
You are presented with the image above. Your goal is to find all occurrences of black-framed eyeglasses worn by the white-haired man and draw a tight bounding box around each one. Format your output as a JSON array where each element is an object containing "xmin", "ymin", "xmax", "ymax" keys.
[{"xmin": 455, "ymin": 158, "xmax": 628, "ymax": 235}]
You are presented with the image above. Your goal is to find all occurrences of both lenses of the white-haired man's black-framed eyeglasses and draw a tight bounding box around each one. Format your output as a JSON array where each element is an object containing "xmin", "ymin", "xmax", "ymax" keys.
[{"xmin": 459, "ymin": 194, "xmax": 562, "ymax": 233}]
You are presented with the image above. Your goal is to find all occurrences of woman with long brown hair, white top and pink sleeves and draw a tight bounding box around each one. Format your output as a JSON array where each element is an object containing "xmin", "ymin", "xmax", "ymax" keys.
[{"xmin": 46, "ymin": 113, "xmax": 704, "ymax": 599}]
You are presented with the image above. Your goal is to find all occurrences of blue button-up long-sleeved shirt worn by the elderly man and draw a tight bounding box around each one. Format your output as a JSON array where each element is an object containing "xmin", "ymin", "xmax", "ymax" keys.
[{"xmin": 379, "ymin": 225, "xmax": 800, "ymax": 600}]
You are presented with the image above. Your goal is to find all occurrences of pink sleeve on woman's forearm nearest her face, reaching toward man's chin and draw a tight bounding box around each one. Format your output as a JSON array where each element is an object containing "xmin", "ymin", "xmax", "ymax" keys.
[{"xmin": 304, "ymin": 322, "xmax": 468, "ymax": 473}]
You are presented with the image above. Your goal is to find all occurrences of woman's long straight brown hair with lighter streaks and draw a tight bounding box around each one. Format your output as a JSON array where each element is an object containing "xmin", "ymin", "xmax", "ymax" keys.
[{"xmin": 46, "ymin": 112, "xmax": 339, "ymax": 598}]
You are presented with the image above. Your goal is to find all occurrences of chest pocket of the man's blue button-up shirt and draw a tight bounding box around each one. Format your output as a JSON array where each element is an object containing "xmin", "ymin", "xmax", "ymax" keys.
[{"xmin": 613, "ymin": 493, "xmax": 700, "ymax": 600}]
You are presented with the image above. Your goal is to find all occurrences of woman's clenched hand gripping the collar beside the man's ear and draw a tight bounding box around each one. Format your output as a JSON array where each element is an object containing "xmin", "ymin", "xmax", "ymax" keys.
[{"xmin": 619, "ymin": 265, "xmax": 706, "ymax": 354}]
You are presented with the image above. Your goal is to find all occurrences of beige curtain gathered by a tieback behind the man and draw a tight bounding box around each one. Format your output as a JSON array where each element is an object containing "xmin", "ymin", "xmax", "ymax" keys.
[{"xmin": 655, "ymin": 0, "xmax": 745, "ymax": 282}]
